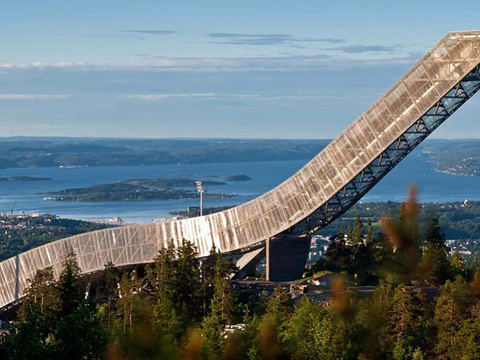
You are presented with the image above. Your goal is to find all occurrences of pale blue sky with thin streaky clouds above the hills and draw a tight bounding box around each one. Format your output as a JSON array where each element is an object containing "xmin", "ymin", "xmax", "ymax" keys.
[{"xmin": 0, "ymin": 0, "xmax": 480, "ymax": 138}]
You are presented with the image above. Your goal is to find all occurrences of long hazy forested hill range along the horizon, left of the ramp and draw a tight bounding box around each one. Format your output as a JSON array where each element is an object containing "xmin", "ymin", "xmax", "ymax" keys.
[{"xmin": 0, "ymin": 137, "xmax": 330, "ymax": 168}]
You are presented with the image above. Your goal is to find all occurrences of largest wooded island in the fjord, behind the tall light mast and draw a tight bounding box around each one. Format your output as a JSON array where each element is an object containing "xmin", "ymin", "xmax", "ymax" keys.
[{"xmin": 43, "ymin": 178, "xmax": 234, "ymax": 201}]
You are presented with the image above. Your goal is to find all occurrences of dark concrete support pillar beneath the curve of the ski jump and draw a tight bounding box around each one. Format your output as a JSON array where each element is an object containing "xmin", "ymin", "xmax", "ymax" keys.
[{"xmin": 265, "ymin": 235, "xmax": 310, "ymax": 281}]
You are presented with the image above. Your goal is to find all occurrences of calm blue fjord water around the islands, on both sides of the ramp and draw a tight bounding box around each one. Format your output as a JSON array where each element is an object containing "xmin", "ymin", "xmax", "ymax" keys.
[{"xmin": 0, "ymin": 148, "xmax": 480, "ymax": 222}]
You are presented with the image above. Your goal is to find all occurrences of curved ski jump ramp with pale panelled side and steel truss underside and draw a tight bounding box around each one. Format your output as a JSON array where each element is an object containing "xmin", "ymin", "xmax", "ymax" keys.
[{"xmin": 0, "ymin": 31, "xmax": 480, "ymax": 308}]
